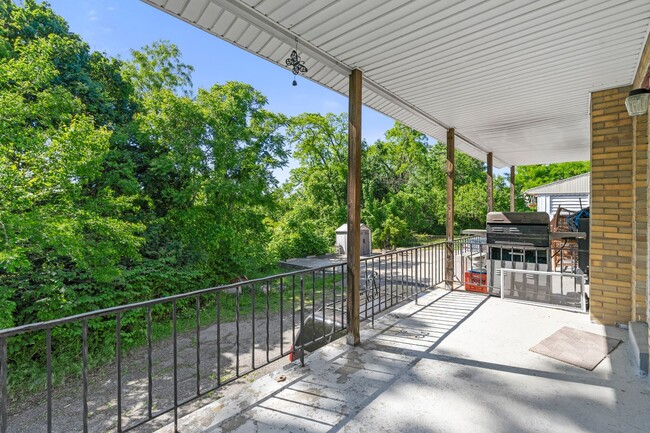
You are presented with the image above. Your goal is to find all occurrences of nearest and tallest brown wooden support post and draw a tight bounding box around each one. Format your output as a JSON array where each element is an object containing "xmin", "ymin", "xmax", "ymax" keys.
[{"xmin": 346, "ymin": 69, "xmax": 362, "ymax": 346}]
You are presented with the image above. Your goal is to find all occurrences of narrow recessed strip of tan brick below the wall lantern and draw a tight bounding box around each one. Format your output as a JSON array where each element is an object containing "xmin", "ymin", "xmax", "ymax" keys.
[{"xmin": 632, "ymin": 111, "xmax": 648, "ymax": 321}]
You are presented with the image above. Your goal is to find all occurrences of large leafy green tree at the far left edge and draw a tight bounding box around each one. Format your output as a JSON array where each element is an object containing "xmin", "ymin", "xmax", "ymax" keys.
[{"xmin": 0, "ymin": 0, "xmax": 142, "ymax": 323}]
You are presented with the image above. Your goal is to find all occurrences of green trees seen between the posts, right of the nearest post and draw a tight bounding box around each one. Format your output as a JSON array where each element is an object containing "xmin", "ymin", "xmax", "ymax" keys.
[{"xmin": 362, "ymin": 123, "xmax": 509, "ymax": 240}]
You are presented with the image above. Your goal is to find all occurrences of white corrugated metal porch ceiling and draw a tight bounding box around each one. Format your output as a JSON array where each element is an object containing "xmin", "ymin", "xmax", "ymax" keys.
[{"xmin": 143, "ymin": 0, "xmax": 650, "ymax": 167}]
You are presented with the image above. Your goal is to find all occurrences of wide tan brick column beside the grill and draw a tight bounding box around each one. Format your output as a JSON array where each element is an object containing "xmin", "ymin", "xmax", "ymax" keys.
[{"xmin": 589, "ymin": 86, "xmax": 634, "ymax": 324}]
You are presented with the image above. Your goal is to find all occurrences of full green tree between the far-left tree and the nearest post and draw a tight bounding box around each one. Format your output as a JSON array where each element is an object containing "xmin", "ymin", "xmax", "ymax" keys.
[{"xmin": 129, "ymin": 72, "xmax": 287, "ymax": 282}]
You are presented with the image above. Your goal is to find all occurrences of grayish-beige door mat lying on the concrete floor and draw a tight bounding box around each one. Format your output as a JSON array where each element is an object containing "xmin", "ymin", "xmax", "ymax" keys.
[{"xmin": 529, "ymin": 326, "xmax": 621, "ymax": 370}]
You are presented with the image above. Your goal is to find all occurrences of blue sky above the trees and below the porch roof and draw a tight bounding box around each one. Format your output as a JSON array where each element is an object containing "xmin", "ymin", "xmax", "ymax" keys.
[{"xmin": 43, "ymin": 0, "xmax": 394, "ymax": 181}]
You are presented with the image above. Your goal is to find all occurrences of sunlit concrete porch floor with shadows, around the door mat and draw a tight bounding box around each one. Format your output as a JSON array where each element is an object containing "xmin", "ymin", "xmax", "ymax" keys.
[{"xmin": 160, "ymin": 289, "xmax": 650, "ymax": 433}]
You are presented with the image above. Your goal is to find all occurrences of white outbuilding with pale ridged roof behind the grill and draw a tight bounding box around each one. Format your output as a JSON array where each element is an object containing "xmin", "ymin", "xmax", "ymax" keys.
[{"xmin": 524, "ymin": 173, "xmax": 591, "ymax": 217}]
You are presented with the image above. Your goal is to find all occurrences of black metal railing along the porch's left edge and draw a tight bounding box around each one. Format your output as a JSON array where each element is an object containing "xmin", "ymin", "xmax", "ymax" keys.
[{"xmin": 0, "ymin": 243, "xmax": 445, "ymax": 433}]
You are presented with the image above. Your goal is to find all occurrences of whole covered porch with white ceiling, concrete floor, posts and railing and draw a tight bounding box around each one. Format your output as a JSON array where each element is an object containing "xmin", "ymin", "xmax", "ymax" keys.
[{"xmin": 0, "ymin": 0, "xmax": 650, "ymax": 433}]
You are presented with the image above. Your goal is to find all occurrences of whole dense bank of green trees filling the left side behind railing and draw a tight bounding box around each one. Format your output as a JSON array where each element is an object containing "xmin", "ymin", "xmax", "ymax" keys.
[{"xmin": 0, "ymin": 0, "xmax": 287, "ymax": 326}]
